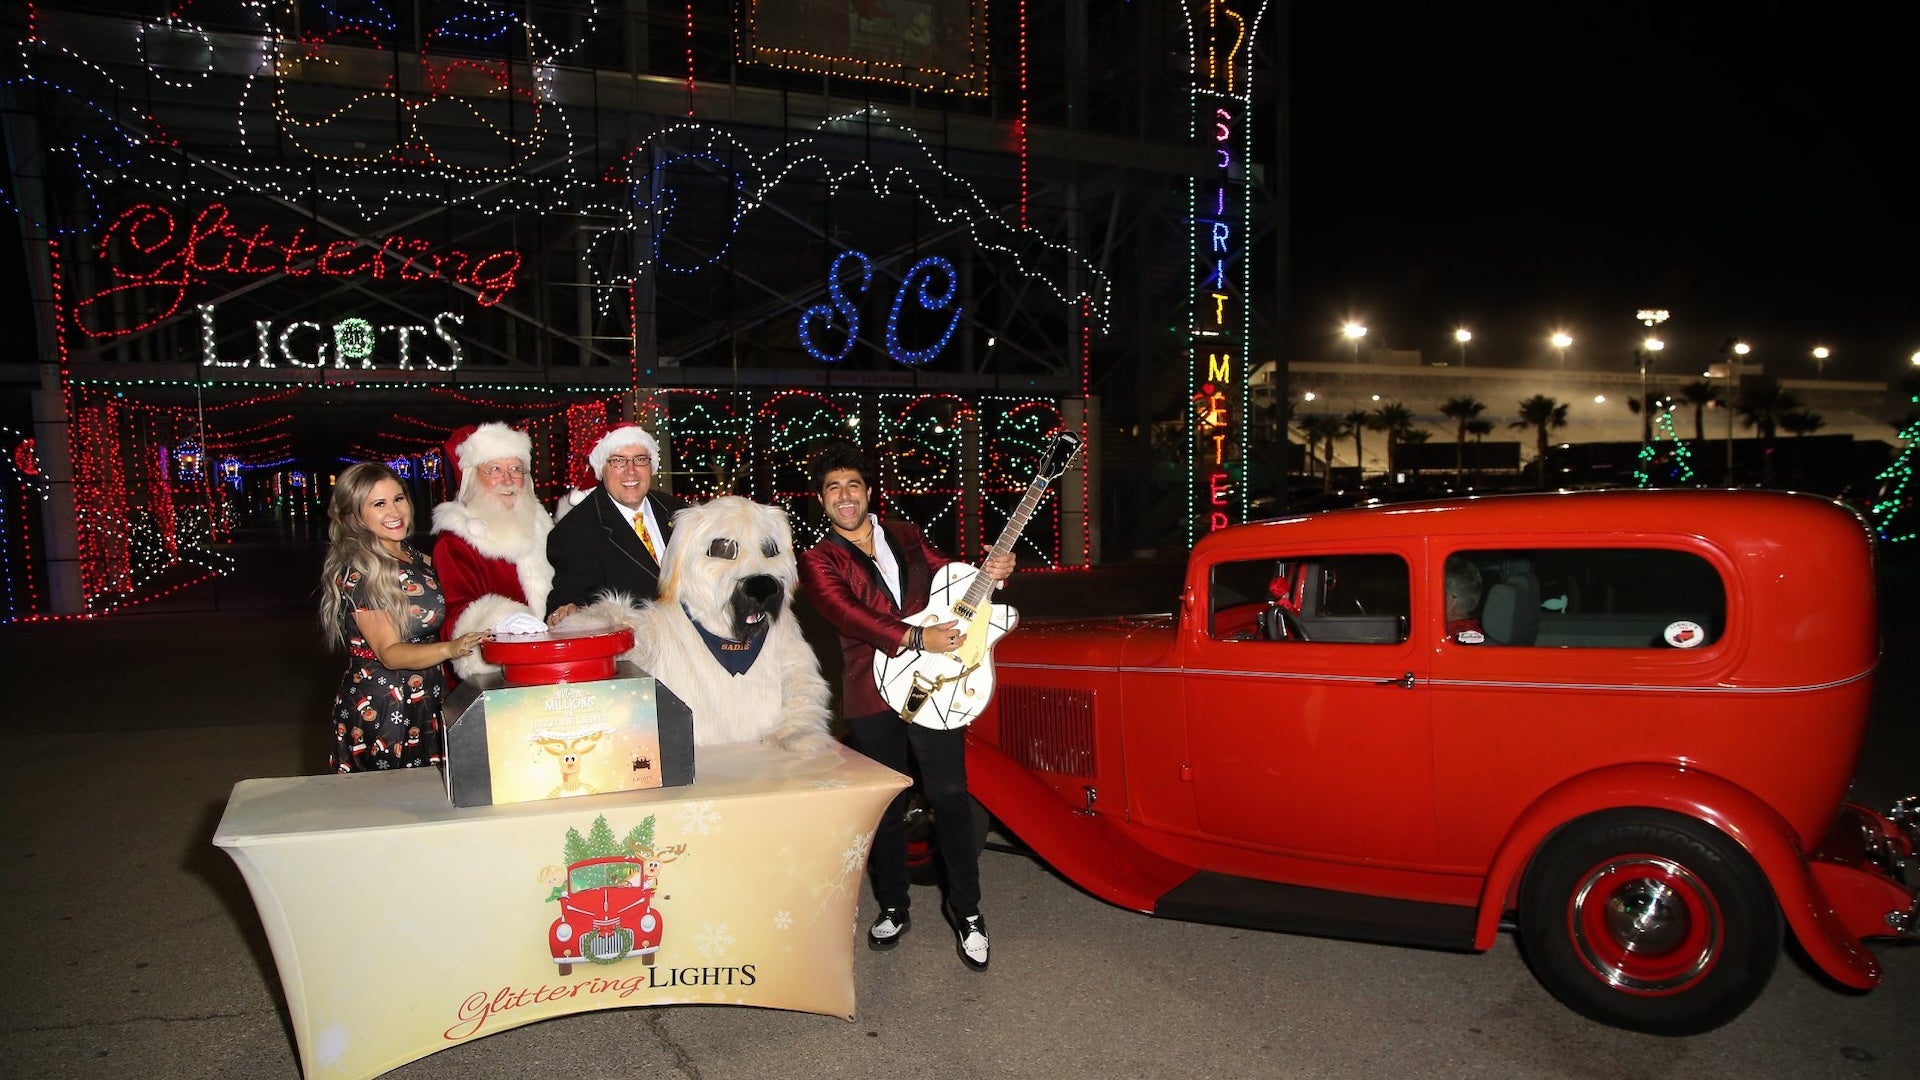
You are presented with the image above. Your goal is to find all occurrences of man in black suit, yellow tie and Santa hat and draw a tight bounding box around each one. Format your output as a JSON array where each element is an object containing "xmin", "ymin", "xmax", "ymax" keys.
[{"xmin": 547, "ymin": 425, "xmax": 687, "ymax": 625}]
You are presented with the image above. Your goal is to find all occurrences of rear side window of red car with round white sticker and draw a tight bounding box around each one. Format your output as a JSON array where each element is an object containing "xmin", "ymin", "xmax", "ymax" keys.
[{"xmin": 1446, "ymin": 548, "xmax": 1726, "ymax": 650}]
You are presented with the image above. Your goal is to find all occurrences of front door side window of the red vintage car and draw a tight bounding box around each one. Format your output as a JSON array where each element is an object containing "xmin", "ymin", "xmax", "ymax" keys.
[{"xmin": 1208, "ymin": 555, "xmax": 1411, "ymax": 646}]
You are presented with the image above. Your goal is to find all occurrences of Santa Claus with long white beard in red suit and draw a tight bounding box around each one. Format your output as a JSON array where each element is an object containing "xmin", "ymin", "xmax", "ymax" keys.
[{"xmin": 434, "ymin": 423, "xmax": 553, "ymax": 678}]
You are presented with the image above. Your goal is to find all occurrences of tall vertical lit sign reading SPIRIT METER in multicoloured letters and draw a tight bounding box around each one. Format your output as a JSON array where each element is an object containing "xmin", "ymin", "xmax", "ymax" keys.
[{"xmin": 1187, "ymin": 0, "xmax": 1265, "ymax": 532}]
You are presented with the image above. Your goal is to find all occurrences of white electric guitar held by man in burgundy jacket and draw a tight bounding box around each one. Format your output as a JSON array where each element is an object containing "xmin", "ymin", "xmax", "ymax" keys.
[{"xmin": 874, "ymin": 432, "xmax": 1081, "ymax": 728}]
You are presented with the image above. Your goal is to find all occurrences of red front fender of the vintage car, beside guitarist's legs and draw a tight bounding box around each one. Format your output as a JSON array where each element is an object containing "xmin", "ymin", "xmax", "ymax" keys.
[{"xmin": 966, "ymin": 736, "xmax": 1194, "ymax": 915}]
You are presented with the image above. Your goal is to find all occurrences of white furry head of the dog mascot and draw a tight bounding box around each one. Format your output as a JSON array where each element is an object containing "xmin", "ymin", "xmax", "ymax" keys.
[{"xmin": 660, "ymin": 496, "xmax": 799, "ymax": 642}]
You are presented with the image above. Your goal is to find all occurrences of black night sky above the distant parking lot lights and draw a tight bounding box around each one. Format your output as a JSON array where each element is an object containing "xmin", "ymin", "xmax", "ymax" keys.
[{"xmin": 1290, "ymin": 0, "xmax": 1920, "ymax": 380}]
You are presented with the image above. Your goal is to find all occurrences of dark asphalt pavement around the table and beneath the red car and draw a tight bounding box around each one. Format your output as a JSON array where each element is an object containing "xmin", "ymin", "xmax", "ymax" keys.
[{"xmin": 0, "ymin": 538, "xmax": 1920, "ymax": 1080}]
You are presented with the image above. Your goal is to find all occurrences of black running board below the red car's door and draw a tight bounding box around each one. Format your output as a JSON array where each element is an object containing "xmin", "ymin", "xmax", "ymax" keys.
[{"xmin": 1154, "ymin": 871, "xmax": 1475, "ymax": 953}]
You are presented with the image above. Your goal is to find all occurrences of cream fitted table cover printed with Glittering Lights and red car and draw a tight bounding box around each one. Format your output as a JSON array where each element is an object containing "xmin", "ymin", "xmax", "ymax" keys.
[{"xmin": 213, "ymin": 746, "xmax": 906, "ymax": 1080}]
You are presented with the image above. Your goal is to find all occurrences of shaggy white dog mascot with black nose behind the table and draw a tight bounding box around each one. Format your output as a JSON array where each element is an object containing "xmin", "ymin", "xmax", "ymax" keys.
[{"xmin": 561, "ymin": 496, "xmax": 833, "ymax": 751}]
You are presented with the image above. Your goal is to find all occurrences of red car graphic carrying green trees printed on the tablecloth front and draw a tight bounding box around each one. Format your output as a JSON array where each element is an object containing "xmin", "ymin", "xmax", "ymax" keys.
[{"xmin": 540, "ymin": 815, "xmax": 687, "ymax": 976}]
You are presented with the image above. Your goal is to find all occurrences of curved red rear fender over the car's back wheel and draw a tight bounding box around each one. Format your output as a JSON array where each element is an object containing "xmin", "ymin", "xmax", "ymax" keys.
[{"xmin": 1473, "ymin": 763, "xmax": 1880, "ymax": 990}]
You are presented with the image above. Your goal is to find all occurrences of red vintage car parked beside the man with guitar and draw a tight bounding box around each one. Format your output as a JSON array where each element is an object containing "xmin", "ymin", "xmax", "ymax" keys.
[{"xmin": 968, "ymin": 492, "xmax": 1916, "ymax": 1034}]
